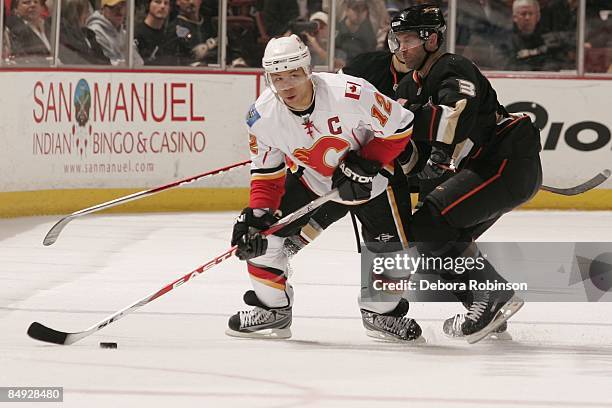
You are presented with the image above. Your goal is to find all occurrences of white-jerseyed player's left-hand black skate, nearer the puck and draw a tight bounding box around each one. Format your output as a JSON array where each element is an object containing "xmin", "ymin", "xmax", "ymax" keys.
[{"xmin": 225, "ymin": 290, "xmax": 291, "ymax": 339}]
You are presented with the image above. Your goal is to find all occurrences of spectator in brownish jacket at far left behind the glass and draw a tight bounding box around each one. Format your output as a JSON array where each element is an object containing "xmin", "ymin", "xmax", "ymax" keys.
[{"xmin": 6, "ymin": 0, "xmax": 51, "ymax": 63}]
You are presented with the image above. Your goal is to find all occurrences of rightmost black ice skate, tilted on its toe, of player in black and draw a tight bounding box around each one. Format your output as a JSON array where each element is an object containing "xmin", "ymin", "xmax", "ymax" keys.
[{"xmin": 461, "ymin": 290, "xmax": 524, "ymax": 344}]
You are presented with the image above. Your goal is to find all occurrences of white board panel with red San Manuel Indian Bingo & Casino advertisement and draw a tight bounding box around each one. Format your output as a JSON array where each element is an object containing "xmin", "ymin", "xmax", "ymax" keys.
[{"xmin": 0, "ymin": 71, "xmax": 258, "ymax": 192}]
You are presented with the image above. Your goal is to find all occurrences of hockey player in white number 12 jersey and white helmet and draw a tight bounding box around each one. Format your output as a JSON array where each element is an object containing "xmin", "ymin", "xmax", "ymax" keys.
[{"xmin": 227, "ymin": 35, "xmax": 421, "ymax": 341}]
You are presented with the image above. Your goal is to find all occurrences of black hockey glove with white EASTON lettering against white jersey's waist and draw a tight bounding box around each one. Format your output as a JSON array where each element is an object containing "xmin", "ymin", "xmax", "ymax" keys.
[{"xmin": 332, "ymin": 150, "xmax": 381, "ymax": 201}]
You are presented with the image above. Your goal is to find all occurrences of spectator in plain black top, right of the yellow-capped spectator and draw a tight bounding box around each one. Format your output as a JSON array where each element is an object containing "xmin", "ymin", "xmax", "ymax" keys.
[{"xmin": 134, "ymin": 0, "xmax": 170, "ymax": 64}]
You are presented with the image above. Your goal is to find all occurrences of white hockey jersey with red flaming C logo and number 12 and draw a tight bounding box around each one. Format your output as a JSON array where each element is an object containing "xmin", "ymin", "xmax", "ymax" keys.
[{"xmin": 247, "ymin": 73, "xmax": 414, "ymax": 208}]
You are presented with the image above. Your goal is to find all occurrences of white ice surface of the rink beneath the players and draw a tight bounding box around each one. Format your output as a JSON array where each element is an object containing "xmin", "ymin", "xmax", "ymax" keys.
[{"xmin": 0, "ymin": 212, "xmax": 612, "ymax": 408}]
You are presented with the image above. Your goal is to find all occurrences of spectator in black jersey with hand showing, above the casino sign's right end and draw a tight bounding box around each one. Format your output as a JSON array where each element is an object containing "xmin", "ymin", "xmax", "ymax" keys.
[{"xmin": 162, "ymin": 0, "xmax": 217, "ymax": 65}]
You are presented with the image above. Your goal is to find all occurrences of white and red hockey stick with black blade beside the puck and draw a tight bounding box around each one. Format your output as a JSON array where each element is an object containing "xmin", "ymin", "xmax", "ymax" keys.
[{"xmin": 28, "ymin": 189, "xmax": 338, "ymax": 345}]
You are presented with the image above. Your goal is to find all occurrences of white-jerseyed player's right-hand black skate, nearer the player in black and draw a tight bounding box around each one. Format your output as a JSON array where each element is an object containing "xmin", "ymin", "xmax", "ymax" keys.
[{"xmin": 361, "ymin": 299, "xmax": 425, "ymax": 343}]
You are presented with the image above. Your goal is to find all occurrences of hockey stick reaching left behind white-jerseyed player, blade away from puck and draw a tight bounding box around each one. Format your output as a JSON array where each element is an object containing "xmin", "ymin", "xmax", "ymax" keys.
[{"xmin": 43, "ymin": 160, "xmax": 251, "ymax": 246}]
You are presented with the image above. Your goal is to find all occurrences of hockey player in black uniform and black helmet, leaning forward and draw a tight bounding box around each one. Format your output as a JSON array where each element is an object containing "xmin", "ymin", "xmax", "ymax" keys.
[{"xmin": 390, "ymin": 5, "xmax": 542, "ymax": 343}]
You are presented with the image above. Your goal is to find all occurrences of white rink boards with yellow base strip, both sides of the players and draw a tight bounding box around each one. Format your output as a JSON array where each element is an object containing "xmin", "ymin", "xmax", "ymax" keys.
[{"xmin": 0, "ymin": 69, "xmax": 612, "ymax": 216}]
